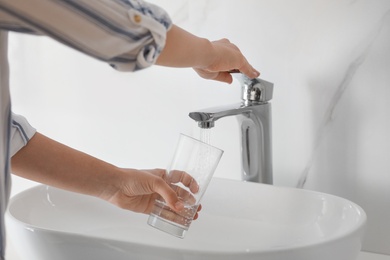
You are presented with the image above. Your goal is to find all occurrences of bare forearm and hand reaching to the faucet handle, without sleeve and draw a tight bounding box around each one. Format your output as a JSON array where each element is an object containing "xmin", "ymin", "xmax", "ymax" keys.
[{"xmin": 156, "ymin": 25, "xmax": 260, "ymax": 83}]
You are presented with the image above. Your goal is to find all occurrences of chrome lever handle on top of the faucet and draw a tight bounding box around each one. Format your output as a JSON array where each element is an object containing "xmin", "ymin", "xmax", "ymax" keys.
[{"xmin": 234, "ymin": 73, "xmax": 274, "ymax": 103}]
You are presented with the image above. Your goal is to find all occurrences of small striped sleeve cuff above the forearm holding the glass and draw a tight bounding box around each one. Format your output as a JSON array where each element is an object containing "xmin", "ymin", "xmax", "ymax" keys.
[{"xmin": 10, "ymin": 113, "xmax": 36, "ymax": 157}]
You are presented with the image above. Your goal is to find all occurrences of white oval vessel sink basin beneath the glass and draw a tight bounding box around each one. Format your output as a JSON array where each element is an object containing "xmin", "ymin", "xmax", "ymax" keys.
[{"xmin": 6, "ymin": 178, "xmax": 366, "ymax": 260}]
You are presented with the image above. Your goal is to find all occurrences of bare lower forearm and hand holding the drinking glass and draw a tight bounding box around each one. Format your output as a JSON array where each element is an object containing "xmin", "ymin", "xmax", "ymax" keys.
[{"xmin": 11, "ymin": 133, "xmax": 190, "ymax": 213}]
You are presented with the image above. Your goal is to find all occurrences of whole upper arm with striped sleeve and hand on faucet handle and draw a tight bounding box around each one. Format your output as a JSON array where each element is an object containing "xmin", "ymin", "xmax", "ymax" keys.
[{"xmin": 0, "ymin": 0, "xmax": 259, "ymax": 80}]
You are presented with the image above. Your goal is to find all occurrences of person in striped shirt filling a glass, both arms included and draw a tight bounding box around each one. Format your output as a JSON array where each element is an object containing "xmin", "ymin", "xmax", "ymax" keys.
[{"xmin": 0, "ymin": 0, "xmax": 259, "ymax": 259}]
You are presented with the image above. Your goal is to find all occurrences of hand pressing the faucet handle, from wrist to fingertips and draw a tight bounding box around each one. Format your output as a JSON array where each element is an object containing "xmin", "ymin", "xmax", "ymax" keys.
[{"xmin": 194, "ymin": 39, "xmax": 260, "ymax": 83}]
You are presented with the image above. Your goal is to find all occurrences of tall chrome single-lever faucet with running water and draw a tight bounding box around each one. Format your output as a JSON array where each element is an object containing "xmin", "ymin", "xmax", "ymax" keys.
[{"xmin": 189, "ymin": 74, "xmax": 273, "ymax": 184}]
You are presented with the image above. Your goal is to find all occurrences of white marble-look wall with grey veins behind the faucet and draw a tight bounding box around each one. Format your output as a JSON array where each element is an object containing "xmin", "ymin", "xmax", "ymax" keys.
[{"xmin": 10, "ymin": 0, "xmax": 390, "ymax": 254}]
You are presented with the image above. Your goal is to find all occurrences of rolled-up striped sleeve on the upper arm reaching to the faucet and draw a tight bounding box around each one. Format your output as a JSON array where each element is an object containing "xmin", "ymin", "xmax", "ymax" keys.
[{"xmin": 0, "ymin": 0, "xmax": 172, "ymax": 71}]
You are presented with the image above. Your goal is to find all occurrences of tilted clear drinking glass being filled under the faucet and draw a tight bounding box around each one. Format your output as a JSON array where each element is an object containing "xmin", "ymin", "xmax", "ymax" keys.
[{"xmin": 148, "ymin": 134, "xmax": 223, "ymax": 238}]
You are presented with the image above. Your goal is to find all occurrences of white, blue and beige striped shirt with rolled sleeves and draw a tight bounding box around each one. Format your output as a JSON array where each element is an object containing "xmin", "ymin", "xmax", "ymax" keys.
[{"xmin": 0, "ymin": 0, "xmax": 172, "ymax": 260}]
